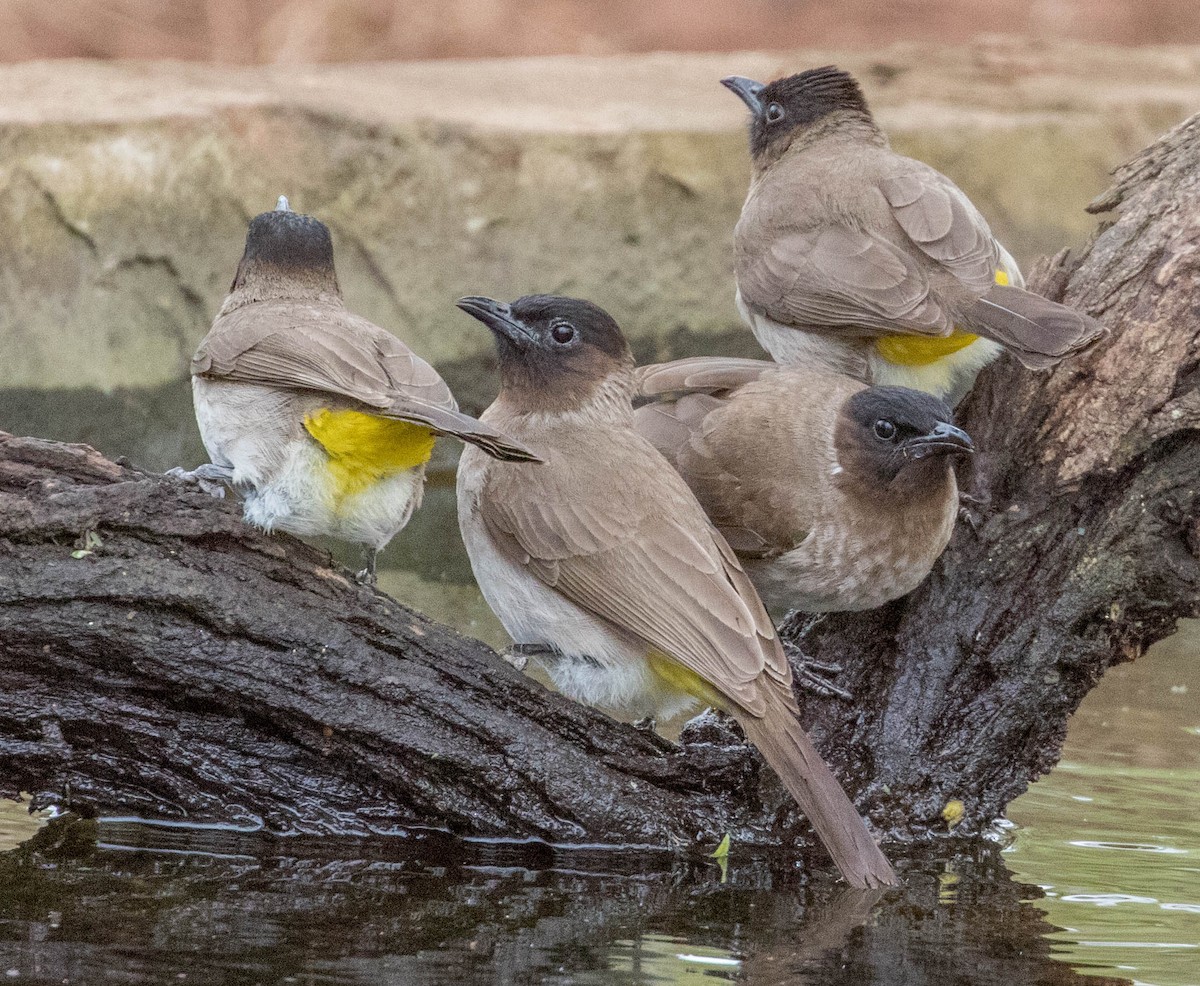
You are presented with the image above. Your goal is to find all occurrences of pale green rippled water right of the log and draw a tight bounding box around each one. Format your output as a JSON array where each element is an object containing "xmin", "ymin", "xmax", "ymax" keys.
[{"xmin": 1006, "ymin": 623, "xmax": 1200, "ymax": 986}]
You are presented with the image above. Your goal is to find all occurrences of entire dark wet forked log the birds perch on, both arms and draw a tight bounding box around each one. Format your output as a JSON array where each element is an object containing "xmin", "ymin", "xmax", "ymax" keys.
[{"xmin": 0, "ymin": 113, "xmax": 1200, "ymax": 847}]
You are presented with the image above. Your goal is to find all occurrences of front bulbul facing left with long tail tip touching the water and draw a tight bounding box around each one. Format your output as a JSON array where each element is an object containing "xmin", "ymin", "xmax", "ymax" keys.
[{"xmin": 458, "ymin": 295, "xmax": 896, "ymax": 886}]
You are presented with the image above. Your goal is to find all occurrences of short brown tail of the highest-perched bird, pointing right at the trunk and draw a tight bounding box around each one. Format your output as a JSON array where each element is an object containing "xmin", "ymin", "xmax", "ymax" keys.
[{"xmin": 961, "ymin": 284, "xmax": 1105, "ymax": 369}]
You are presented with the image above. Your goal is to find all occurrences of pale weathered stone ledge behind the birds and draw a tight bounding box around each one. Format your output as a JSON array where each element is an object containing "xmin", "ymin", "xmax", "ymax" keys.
[{"xmin": 0, "ymin": 30, "xmax": 1200, "ymax": 468}]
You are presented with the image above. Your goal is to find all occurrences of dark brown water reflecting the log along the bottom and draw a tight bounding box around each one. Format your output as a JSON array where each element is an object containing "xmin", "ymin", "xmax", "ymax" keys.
[{"xmin": 0, "ymin": 822, "xmax": 1118, "ymax": 986}]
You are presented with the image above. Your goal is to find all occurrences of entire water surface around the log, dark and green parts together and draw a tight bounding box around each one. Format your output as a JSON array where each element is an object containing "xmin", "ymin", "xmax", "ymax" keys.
[{"xmin": 0, "ymin": 419, "xmax": 1200, "ymax": 986}]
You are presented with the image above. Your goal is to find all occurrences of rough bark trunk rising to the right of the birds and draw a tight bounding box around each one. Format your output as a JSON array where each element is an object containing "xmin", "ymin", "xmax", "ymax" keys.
[{"xmin": 792, "ymin": 118, "xmax": 1200, "ymax": 838}]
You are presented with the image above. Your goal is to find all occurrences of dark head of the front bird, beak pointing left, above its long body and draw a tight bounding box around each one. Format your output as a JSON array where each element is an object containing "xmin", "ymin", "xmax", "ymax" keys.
[{"xmin": 457, "ymin": 294, "xmax": 634, "ymax": 410}]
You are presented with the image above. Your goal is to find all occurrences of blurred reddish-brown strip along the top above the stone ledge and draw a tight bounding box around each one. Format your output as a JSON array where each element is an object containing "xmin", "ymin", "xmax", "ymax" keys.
[{"xmin": 0, "ymin": 0, "xmax": 1200, "ymax": 65}]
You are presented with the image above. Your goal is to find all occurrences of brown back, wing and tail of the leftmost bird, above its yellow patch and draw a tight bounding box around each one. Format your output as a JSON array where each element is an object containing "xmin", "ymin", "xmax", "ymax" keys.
[{"xmin": 192, "ymin": 301, "xmax": 538, "ymax": 461}]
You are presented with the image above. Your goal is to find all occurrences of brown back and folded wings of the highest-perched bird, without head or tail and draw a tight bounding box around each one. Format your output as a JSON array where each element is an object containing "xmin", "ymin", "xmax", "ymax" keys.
[{"xmin": 737, "ymin": 148, "xmax": 1020, "ymax": 335}]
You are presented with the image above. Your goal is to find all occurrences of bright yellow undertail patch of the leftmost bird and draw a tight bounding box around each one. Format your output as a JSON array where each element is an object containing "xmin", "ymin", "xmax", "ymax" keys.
[{"xmin": 304, "ymin": 408, "xmax": 437, "ymax": 500}]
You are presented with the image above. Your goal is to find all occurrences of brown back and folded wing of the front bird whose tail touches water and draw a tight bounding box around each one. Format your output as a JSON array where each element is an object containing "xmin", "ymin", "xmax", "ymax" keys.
[{"xmin": 480, "ymin": 428, "xmax": 793, "ymax": 716}]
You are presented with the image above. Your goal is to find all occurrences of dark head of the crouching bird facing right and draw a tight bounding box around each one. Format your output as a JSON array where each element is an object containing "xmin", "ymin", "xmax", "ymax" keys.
[{"xmin": 834, "ymin": 386, "xmax": 974, "ymax": 497}]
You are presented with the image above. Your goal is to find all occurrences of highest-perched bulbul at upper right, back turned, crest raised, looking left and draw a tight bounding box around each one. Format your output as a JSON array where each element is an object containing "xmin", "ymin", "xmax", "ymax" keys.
[{"xmin": 721, "ymin": 66, "xmax": 1104, "ymax": 402}]
